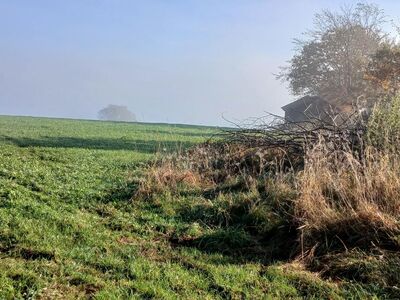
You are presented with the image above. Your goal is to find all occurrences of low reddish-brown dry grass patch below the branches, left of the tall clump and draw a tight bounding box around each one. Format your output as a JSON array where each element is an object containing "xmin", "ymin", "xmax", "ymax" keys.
[{"xmin": 136, "ymin": 142, "xmax": 285, "ymax": 197}]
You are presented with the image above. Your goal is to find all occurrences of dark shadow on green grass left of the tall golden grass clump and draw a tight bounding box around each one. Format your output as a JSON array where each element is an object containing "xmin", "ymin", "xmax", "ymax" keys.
[{"xmin": 161, "ymin": 190, "xmax": 299, "ymax": 265}]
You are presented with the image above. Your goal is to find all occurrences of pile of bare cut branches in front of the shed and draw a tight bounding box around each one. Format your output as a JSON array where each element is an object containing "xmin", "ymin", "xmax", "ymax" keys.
[{"xmin": 220, "ymin": 114, "xmax": 365, "ymax": 157}]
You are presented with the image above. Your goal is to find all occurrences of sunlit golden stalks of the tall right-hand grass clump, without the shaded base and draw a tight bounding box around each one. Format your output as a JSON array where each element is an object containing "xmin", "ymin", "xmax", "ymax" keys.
[{"xmin": 295, "ymin": 143, "xmax": 400, "ymax": 229}]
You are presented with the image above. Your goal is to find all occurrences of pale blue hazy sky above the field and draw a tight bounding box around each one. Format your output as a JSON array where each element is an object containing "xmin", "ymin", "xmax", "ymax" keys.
[{"xmin": 0, "ymin": 0, "xmax": 400, "ymax": 125}]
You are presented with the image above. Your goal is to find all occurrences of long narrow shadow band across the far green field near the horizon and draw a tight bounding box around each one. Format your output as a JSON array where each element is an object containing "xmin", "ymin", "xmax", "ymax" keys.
[{"xmin": 4, "ymin": 136, "xmax": 195, "ymax": 153}]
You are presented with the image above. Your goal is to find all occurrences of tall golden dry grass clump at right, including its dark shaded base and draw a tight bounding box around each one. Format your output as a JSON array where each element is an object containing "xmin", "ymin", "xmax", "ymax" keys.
[{"xmin": 294, "ymin": 142, "xmax": 400, "ymax": 249}]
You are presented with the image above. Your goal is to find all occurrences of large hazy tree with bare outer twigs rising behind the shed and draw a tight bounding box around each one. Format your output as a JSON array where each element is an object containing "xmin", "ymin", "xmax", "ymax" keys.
[{"xmin": 278, "ymin": 4, "xmax": 386, "ymax": 110}]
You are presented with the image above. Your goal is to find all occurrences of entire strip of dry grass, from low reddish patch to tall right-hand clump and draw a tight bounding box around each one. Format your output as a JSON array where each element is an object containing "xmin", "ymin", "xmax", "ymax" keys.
[{"xmin": 138, "ymin": 97, "xmax": 400, "ymax": 255}]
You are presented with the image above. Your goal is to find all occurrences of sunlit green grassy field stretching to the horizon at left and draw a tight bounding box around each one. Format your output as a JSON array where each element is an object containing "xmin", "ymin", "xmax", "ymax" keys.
[{"xmin": 0, "ymin": 116, "xmax": 384, "ymax": 299}]
